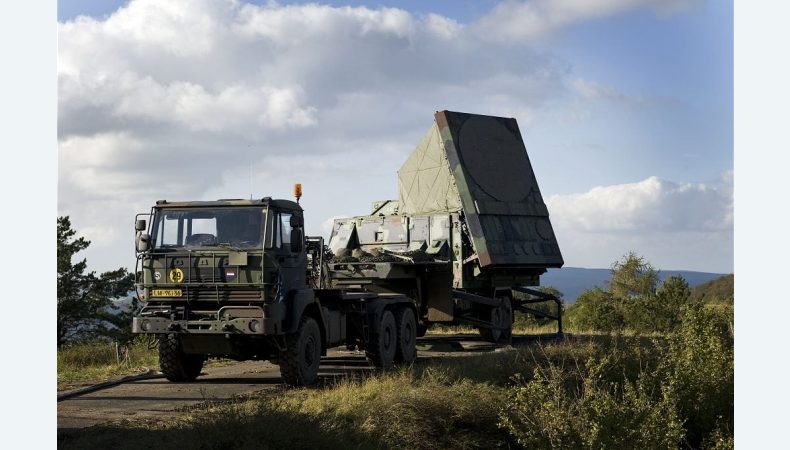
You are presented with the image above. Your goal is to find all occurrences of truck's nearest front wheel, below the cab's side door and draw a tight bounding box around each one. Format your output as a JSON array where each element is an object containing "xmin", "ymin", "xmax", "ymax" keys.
[{"xmin": 278, "ymin": 316, "xmax": 321, "ymax": 386}]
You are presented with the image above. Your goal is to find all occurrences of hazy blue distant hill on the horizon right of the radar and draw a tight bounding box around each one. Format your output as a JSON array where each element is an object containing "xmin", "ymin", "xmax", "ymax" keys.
[{"xmin": 540, "ymin": 267, "xmax": 732, "ymax": 304}]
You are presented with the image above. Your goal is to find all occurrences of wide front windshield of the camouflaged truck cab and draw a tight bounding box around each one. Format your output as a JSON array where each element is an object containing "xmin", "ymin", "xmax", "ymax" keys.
[{"xmin": 151, "ymin": 207, "xmax": 266, "ymax": 250}]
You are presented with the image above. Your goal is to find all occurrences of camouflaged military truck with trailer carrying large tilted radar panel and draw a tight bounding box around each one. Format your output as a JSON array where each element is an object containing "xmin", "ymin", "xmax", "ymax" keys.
[{"xmin": 132, "ymin": 111, "xmax": 563, "ymax": 385}]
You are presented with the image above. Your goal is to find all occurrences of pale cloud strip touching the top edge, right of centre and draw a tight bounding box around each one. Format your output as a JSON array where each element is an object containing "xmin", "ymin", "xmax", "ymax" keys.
[{"xmin": 476, "ymin": 0, "xmax": 704, "ymax": 41}]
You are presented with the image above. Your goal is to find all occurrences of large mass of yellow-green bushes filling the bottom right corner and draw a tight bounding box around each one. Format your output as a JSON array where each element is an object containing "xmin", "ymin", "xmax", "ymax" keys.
[{"xmin": 500, "ymin": 304, "xmax": 734, "ymax": 449}]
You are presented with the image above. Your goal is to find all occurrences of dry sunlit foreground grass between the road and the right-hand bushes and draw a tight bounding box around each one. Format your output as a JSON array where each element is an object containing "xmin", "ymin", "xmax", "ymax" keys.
[{"xmin": 59, "ymin": 336, "xmax": 676, "ymax": 449}]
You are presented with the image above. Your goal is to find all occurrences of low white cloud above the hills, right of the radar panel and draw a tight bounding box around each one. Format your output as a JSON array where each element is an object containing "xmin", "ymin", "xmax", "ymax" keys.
[{"xmin": 546, "ymin": 172, "xmax": 733, "ymax": 272}]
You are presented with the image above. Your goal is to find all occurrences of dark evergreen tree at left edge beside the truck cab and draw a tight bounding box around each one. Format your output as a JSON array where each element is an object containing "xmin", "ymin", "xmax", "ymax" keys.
[{"xmin": 57, "ymin": 216, "xmax": 134, "ymax": 347}]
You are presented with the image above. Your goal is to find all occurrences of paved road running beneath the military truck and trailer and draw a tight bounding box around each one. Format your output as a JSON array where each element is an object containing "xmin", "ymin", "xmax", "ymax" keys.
[{"xmin": 58, "ymin": 336, "xmax": 556, "ymax": 431}]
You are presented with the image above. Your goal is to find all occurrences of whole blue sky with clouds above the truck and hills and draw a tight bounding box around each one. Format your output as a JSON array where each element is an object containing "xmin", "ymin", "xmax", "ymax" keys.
[{"xmin": 58, "ymin": 0, "xmax": 734, "ymax": 273}]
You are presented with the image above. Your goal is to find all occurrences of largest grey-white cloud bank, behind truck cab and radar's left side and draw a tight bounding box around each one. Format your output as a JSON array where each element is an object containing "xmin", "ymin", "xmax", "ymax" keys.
[{"xmin": 58, "ymin": 0, "xmax": 716, "ymax": 274}]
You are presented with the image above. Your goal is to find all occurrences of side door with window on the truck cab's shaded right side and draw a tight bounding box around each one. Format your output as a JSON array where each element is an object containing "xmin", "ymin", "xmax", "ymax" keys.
[{"xmin": 274, "ymin": 211, "xmax": 307, "ymax": 293}]
